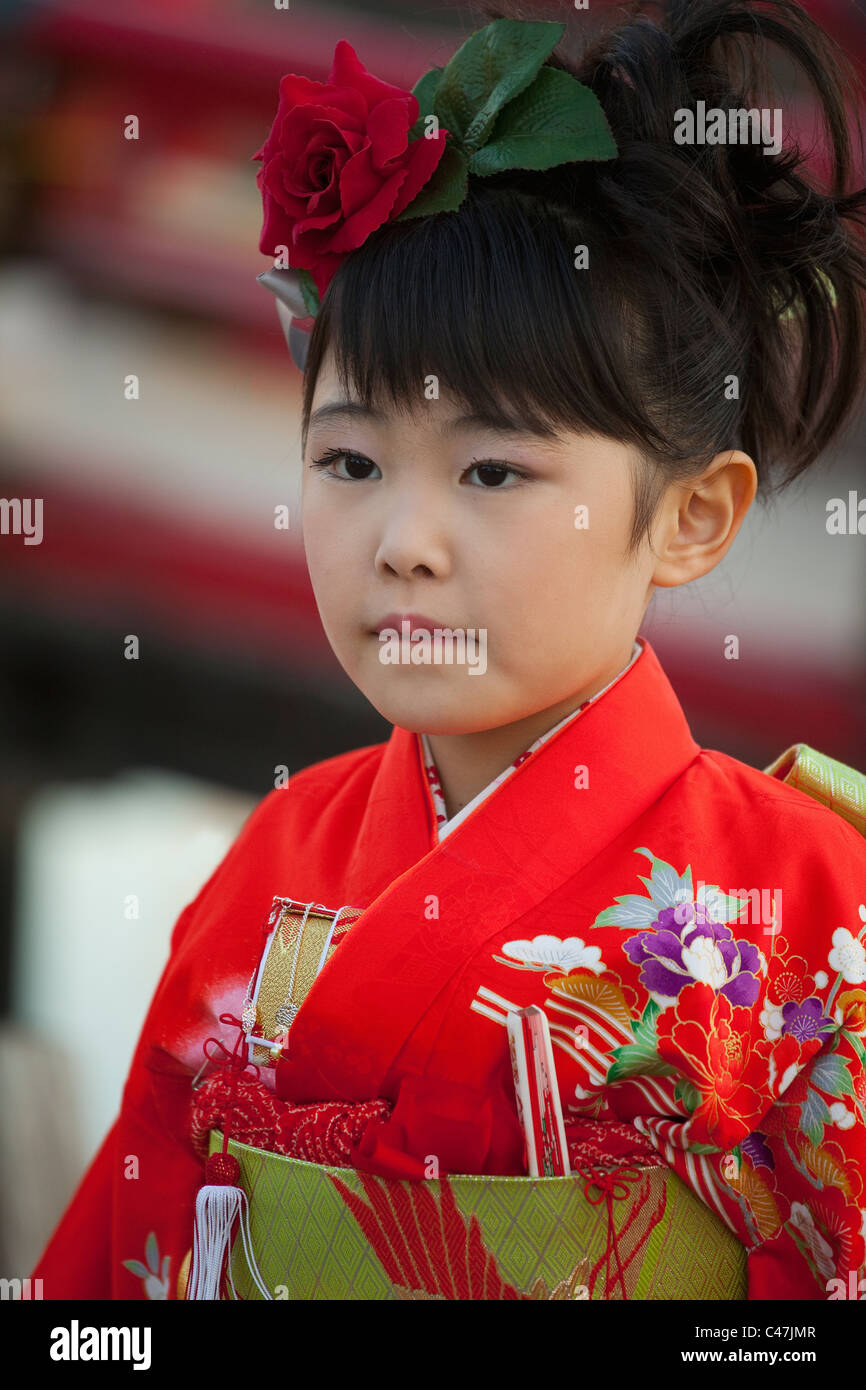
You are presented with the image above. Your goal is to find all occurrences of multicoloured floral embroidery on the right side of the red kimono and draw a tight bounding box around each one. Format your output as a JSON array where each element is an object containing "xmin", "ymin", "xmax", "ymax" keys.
[{"xmin": 493, "ymin": 849, "xmax": 866, "ymax": 1287}]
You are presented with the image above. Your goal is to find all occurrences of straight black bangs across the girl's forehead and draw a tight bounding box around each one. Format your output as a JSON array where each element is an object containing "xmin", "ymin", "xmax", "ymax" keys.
[{"xmin": 303, "ymin": 179, "xmax": 681, "ymax": 455}]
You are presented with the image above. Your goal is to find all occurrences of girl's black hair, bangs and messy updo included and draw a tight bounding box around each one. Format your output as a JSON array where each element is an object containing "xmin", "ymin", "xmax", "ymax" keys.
[{"xmin": 303, "ymin": 0, "xmax": 866, "ymax": 555}]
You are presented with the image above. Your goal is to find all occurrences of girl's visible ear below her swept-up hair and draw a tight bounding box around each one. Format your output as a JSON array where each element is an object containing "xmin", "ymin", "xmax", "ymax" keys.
[{"xmin": 652, "ymin": 449, "xmax": 758, "ymax": 588}]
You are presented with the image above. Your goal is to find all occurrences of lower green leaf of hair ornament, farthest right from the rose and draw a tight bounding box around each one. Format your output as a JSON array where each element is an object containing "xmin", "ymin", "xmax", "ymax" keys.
[{"xmin": 468, "ymin": 68, "xmax": 619, "ymax": 177}]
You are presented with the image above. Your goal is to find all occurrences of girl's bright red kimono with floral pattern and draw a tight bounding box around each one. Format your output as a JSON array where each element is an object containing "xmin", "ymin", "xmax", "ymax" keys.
[{"xmin": 33, "ymin": 639, "xmax": 866, "ymax": 1300}]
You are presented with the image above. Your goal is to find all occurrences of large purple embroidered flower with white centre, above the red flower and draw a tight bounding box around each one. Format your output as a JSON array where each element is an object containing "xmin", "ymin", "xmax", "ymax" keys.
[{"xmin": 624, "ymin": 902, "xmax": 760, "ymax": 1006}]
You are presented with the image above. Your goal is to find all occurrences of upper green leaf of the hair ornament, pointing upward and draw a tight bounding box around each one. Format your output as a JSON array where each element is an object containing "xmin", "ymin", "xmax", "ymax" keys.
[{"xmin": 435, "ymin": 19, "xmax": 566, "ymax": 154}]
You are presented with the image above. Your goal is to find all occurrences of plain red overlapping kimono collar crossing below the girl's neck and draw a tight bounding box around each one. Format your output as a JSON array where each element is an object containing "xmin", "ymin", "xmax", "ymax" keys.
[{"xmin": 291, "ymin": 638, "xmax": 701, "ymax": 1099}]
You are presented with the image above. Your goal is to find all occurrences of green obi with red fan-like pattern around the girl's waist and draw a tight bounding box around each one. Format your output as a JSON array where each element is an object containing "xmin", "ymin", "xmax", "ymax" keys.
[{"xmin": 210, "ymin": 1130, "xmax": 746, "ymax": 1301}]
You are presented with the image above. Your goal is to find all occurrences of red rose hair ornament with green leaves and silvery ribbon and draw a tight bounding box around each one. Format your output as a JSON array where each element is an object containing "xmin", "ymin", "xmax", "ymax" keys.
[{"xmin": 253, "ymin": 19, "xmax": 619, "ymax": 370}]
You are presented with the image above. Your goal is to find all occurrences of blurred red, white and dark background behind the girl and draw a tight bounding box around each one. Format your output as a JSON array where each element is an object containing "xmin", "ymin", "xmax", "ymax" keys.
[{"xmin": 0, "ymin": 0, "xmax": 866, "ymax": 1277}]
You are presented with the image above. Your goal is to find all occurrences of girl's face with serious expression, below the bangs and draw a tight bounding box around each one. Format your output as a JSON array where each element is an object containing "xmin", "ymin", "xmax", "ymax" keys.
[{"xmin": 302, "ymin": 354, "xmax": 655, "ymax": 734}]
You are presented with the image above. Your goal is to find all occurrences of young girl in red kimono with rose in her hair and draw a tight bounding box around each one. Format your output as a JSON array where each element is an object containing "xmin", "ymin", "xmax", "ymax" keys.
[{"xmin": 35, "ymin": 0, "xmax": 866, "ymax": 1300}]
